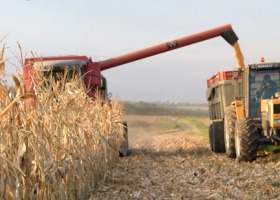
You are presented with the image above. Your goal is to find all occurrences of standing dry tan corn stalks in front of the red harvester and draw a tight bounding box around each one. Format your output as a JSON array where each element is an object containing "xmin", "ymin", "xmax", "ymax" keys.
[{"xmin": 0, "ymin": 41, "xmax": 123, "ymax": 199}]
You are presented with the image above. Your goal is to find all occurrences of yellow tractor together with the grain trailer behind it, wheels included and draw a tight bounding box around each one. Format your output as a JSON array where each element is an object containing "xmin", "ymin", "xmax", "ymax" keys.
[{"xmin": 206, "ymin": 63, "xmax": 280, "ymax": 161}]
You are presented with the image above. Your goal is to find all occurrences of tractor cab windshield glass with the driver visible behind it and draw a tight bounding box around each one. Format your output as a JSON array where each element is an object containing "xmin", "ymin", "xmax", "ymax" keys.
[{"xmin": 249, "ymin": 70, "xmax": 280, "ymax": 117}]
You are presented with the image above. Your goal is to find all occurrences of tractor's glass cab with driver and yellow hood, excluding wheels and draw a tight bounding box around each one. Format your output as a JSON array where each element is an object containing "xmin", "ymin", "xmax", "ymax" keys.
[{"xmin": 248, "ymin": 63, "xmax": 280, "ymax": 139}]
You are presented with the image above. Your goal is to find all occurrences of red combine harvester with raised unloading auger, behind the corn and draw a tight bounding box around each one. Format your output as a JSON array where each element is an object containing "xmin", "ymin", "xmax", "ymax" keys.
[{"xmin": 23, "ymin": 24, "xmax": 238, "ymax": 156}]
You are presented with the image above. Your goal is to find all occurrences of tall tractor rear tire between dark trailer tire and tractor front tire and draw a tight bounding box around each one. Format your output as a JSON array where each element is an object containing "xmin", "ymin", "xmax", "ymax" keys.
[{"xmin": 224, "ymin": 106, "xmax": 236, "ymax": 158}]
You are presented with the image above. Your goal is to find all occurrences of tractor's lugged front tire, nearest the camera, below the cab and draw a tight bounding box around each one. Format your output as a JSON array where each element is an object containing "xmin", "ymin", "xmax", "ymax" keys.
[{"xmin": 235, "ymin": 118, "xmax": 258, "ymax": 162}]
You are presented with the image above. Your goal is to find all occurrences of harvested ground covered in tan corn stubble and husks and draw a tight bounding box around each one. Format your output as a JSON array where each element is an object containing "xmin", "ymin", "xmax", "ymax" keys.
[{"xmin": 91, "ymin": 115, "xmax": 280, "ymax": 200}]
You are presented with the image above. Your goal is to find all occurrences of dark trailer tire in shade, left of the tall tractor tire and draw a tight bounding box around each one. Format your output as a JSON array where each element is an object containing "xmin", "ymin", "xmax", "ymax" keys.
[{"xmin": 212, "ymin": 121, "xmax": 225, "ymax": 153}]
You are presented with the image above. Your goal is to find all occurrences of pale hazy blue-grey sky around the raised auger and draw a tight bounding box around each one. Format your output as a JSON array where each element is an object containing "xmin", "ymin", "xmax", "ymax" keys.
[{"xmin": 0, "ymin": 0, "xmax": 280, "ymax": 103}]
